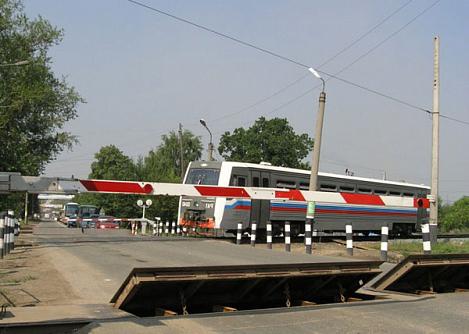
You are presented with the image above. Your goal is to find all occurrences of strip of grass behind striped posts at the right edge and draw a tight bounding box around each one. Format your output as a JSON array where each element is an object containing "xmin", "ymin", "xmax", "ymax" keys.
[{"xmin": 370, "ymin": 241, "xmax": 469, "ymax": 256}]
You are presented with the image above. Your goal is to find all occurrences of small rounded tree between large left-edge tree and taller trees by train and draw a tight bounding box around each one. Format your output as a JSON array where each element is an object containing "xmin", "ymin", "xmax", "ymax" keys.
[{"xmin": 76, "ymin": 145, "xmax": 140, "ymax": 218}]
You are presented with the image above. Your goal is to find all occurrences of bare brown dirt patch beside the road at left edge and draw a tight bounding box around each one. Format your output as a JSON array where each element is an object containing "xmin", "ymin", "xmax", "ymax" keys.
[{"xmin": 0, "ymin": 236, "xmax": 77, "ymax": 306}]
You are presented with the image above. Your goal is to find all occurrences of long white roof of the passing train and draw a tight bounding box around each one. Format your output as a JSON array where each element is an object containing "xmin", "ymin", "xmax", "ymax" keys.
[{"xmin": 191, "ymin": 161, "xmax": 430, "ymax": 190}]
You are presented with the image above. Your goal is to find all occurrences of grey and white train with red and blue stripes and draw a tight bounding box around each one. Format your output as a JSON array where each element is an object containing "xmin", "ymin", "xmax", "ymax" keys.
[{"xmin": 178, "ymin": 161, "xmax": 430, "ymax": 236}]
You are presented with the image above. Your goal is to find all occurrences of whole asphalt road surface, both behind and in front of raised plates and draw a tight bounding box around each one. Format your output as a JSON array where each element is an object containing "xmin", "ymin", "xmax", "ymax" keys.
[{"xmin": 0, "ymin": 222, "xmax": 469, "ymax": 334}]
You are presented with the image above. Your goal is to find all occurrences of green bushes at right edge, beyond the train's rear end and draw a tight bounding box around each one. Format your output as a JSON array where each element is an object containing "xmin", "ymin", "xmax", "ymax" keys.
[{"xmin": 439, "ymin": 197, "xmax": 469, "ymax": 231}]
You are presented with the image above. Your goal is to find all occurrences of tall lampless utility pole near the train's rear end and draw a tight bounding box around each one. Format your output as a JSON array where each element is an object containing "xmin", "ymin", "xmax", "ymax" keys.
[{"xmin": 429, "ymin": 36, "xmax": 440, "ymax": 244}]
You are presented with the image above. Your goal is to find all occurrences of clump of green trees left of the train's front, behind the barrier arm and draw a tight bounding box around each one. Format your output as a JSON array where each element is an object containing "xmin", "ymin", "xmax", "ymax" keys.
[{"xmin": 76, "ymin": 131, "xmax": 202, "ymax": 220}]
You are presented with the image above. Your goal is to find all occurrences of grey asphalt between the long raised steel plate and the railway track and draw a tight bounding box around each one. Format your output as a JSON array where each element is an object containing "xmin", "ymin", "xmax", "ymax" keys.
[{"xmin": 34, "ymin": 222, "xmax": 355, "ymax": 303}]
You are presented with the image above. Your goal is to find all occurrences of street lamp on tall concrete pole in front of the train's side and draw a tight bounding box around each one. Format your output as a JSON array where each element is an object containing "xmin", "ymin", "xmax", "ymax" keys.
[{"xmin": 305, "ymin": 67, "xmax": 326, "ymax": 254}]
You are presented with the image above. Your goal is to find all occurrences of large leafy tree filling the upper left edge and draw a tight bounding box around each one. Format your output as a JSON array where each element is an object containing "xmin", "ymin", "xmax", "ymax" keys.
[{"xmin": 0, "ymin": 0, "xmax": 83, "ymax": 212}]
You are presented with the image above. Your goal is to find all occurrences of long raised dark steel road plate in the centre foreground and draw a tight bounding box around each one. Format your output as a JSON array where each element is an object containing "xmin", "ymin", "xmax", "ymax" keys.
[{"xmin": 111, "ymin": 261, "xmax": 382, "ymax": 316}]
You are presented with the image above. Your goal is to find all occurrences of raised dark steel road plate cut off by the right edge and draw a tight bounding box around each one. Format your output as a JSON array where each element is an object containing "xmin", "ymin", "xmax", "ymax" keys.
[{"xmin": 372, "ymin": 254, "xmax": 469, "ymax": 294}]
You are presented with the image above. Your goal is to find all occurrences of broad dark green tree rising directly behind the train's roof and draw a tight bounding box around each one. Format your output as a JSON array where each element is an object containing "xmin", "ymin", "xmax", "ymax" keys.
[{"xmin": 218, "ymin": 117, "xmax": 313, "ymax": 168}]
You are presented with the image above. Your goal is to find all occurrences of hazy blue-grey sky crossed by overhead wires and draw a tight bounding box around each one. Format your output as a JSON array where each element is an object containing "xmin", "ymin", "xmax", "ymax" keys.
[{"xmin": 23, "ymin": 0, "xmax": 469, "ymax": 202}]
